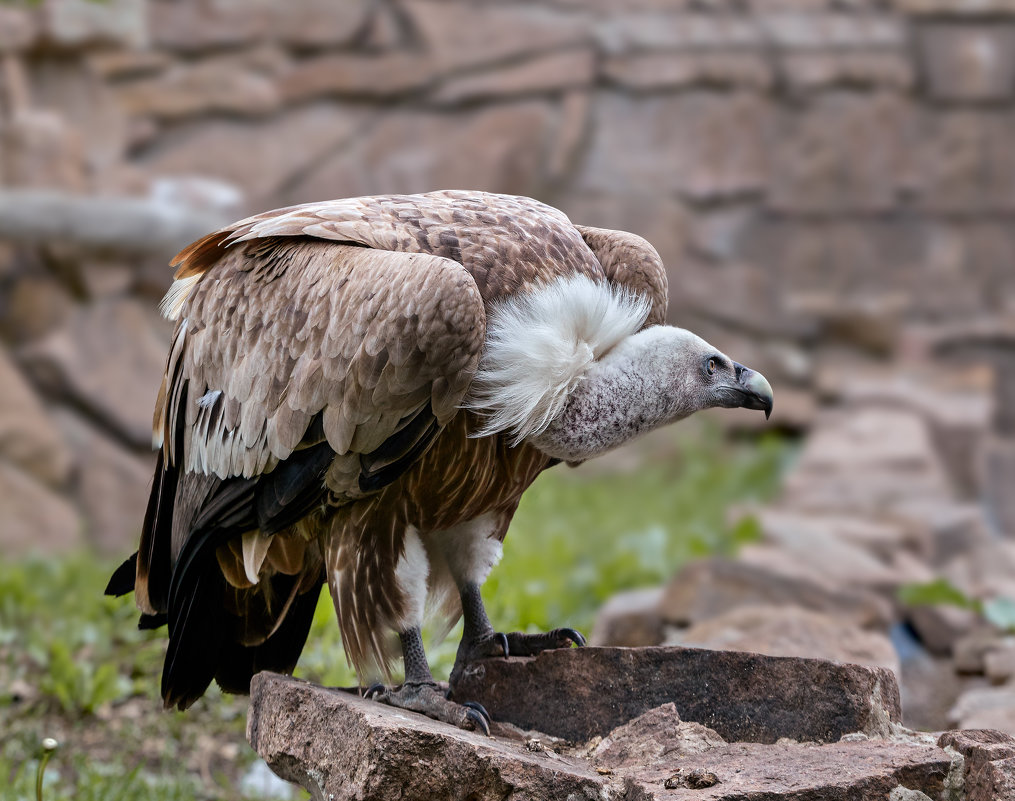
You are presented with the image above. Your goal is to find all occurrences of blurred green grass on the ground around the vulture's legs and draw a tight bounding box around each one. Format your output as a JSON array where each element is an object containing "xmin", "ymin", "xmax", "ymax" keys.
[{"xmin": 0, "ymin": 426, "xmax": 789, "ymax": 801}]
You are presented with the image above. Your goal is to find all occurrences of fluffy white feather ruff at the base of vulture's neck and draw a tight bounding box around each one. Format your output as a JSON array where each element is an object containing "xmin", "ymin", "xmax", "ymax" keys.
[{"xmin": 464, "ymin": 275, "xmax": 651, "ymax": 445}]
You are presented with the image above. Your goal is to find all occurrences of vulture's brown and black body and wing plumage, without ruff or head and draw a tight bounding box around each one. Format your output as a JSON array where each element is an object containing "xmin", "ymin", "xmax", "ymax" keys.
[{"xmin": 111, "ymin": 192, "xmax": 666, "ymax": 707}]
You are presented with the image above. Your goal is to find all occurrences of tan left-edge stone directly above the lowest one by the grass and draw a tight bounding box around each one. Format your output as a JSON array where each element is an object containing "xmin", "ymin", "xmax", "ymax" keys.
[{"xmin": 0, "ymin": 347, "xmax": 71, "ymax": 487}]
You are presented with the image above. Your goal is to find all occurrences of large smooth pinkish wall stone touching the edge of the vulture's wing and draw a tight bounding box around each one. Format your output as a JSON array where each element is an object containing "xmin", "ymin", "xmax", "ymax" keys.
[{"xmin": 23, "ymin": 299, "xmax": 167, "ymax": 448}]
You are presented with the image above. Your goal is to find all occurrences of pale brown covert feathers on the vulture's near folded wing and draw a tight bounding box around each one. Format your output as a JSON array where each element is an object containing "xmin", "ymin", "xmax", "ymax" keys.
[{"xmin": 155, "ymin": 238, "xmax": 486, "ymax": 487}]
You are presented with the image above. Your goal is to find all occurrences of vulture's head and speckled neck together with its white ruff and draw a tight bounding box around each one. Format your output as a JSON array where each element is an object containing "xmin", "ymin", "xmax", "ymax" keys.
[{"xmin": 469, "ymin": 276, "xmax": 772, "ymax": 462}]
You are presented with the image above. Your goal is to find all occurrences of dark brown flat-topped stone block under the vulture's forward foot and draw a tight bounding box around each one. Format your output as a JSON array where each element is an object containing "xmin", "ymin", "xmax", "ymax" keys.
[{"xmin": 454, "ymin": 647, "xmax": 902, "ymax": 743}]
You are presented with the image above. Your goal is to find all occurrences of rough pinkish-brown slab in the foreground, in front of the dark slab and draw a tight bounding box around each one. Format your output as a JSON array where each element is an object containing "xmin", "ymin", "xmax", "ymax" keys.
[{"xmin": 248, "ymin": 673, "xmax": 950, "ymax": 801}]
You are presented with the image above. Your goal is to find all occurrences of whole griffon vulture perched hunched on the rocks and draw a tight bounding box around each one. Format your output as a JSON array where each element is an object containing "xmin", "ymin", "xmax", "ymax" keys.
[{"xmin": 107, "ymin": 187, "xmax": 772, "ymax": 730}]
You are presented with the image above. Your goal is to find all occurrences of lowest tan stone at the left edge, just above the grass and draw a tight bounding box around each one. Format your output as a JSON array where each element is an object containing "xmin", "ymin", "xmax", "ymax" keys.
[{"xmin": 0, "ymin": 459, "xmax": 83, "ymax": 558}]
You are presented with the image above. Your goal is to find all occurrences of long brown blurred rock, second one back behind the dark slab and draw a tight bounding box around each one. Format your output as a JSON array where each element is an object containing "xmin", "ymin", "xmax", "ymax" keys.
[{"xmin": 657, "ymin": 558, "xmax": 892, "ymax": 629}]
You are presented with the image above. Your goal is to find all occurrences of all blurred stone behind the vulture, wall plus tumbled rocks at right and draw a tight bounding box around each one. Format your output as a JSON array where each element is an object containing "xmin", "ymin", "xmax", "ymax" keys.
[{"xmin": 0, "ymin": 0, "xmax": 1015, "ymax": 731}]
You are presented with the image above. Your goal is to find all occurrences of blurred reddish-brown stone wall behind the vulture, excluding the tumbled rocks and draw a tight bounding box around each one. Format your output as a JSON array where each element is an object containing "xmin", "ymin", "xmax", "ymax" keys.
[{"xmin": 0, "ymin": 0, "xmax": 1015, "ymax": 550}]
